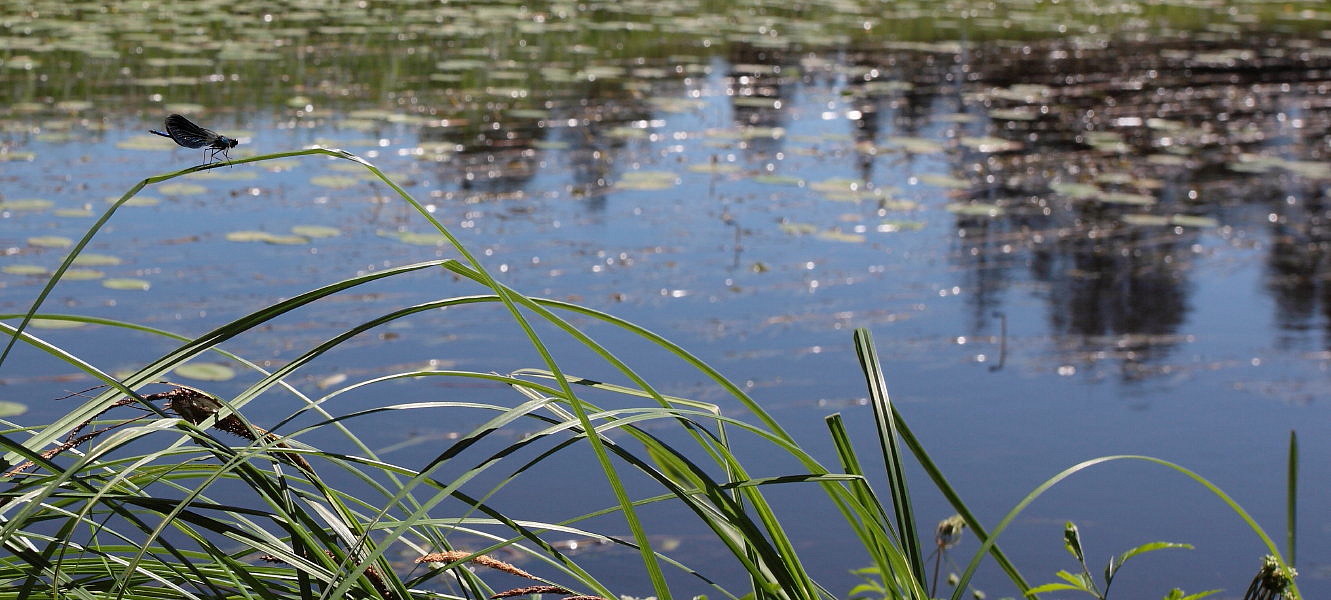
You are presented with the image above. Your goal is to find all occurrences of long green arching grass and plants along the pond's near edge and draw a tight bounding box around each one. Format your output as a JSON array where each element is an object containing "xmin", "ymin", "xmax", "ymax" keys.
[{"xmin": 0, "ymin": 148, "xmax": 1302, "ymax": 600}]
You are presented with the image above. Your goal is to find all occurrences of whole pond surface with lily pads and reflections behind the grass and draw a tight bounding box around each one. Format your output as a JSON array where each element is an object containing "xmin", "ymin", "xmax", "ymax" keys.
[{"xmin": 0, "ymin": 0, "xmax": 1331, "ymax": 597}]
